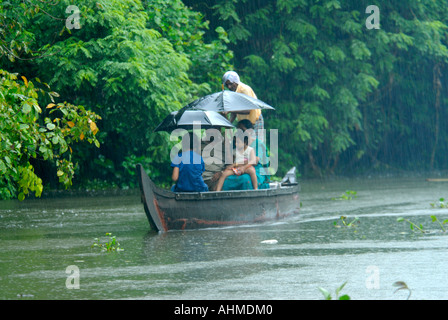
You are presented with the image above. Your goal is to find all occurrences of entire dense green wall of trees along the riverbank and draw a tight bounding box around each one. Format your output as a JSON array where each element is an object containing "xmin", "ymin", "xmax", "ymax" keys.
[{"xmin": 0, "ymin": 0, "xmax": 448, "ymax": 199}]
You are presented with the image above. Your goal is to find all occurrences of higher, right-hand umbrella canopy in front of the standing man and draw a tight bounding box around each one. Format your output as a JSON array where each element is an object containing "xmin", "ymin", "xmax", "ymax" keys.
[{"xmin": 185, "ymin": 90, "xmax": 274, "ymax": 112}]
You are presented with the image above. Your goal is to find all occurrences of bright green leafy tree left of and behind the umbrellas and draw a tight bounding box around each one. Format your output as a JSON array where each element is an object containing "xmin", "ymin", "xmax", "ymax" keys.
[{"xmin": 0, "ymin": 0, "xmax": 232, "ymax": 190}]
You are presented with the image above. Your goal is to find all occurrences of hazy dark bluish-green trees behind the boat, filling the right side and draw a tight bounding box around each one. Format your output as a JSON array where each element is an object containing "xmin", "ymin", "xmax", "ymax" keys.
[{"xmin": 193, "ymin": 0, "xmax": 448, "ymax": 175}]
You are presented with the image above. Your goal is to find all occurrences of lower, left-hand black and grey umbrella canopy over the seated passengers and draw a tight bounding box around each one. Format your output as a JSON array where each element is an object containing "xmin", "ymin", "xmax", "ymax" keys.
[{"xmin": 154, "ymin": 107, "xmax": 234, "ymax": 132}]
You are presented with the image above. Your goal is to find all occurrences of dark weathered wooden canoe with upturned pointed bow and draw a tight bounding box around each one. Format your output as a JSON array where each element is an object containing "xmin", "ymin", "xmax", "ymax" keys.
[{"xmin": 136, "ymin": 164, "xmax": 300, "ymax": 232}]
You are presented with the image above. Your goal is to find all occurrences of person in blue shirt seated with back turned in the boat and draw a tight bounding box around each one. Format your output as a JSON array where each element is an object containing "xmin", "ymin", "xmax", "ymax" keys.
[{"xmin": 171, "ymin": 133, "xmax": 208, "ymax": 192}]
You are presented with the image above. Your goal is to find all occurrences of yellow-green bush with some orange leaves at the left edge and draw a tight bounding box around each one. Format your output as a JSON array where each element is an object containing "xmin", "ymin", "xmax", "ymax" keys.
[{"xmin": 0, "ymin": 70, "xmax": 100, "ymax": 200}]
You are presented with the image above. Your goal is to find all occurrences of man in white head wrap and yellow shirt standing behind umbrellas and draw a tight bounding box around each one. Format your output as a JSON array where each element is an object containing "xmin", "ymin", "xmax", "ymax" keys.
[{"xmin": 222, "ymin": 71, "xmax": 264, "ymax": 141}]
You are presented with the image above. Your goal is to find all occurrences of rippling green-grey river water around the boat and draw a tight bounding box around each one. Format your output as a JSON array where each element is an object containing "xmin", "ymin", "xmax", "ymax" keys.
[{"xmin": 0, "ymin": 178, "xmax": 448, "ymax": 300}]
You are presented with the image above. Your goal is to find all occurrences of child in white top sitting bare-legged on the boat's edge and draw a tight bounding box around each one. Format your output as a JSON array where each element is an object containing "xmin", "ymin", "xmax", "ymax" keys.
[{"xmin": 216, "ymin": 136, "xmax": 258, "ymax": 191}]
